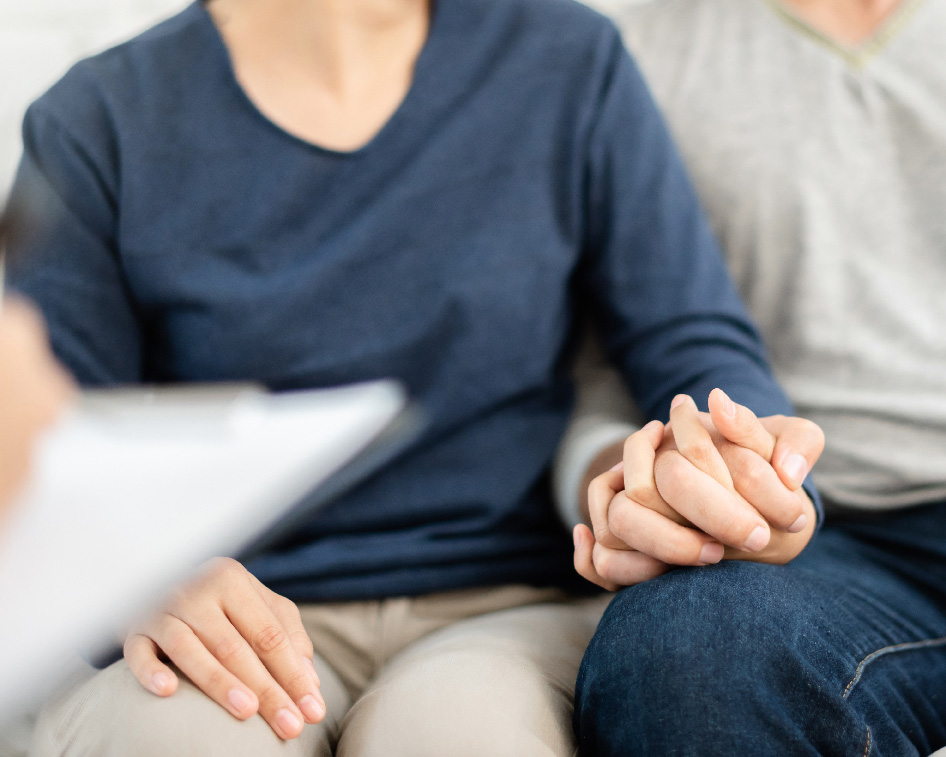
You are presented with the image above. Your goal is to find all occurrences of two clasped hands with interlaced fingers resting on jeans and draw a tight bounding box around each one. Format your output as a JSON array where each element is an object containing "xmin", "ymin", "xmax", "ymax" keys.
[{"xmin": 574, "ymin": 389, "xmax": 824, "ymax": 591}]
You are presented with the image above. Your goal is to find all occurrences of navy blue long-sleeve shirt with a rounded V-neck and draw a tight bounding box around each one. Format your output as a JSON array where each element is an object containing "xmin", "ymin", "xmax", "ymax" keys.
[{"xmin": 10, "ymin": 0, "xmax": 804, "ymax": 600}]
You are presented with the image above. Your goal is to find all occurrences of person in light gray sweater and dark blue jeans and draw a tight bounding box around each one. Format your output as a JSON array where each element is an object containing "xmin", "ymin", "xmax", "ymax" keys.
[{"xmin": 557, "ymin": 0, "xmax": 946, "ymax": 755}]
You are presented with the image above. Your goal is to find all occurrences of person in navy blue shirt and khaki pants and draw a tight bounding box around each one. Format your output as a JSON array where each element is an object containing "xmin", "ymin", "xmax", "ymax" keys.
[{"xmin": 10, "ymin": 0, "xmax": 817, "ymax": 756}]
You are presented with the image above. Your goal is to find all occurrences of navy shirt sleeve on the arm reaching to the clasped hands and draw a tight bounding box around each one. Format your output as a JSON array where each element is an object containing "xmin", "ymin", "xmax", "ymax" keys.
[{"xmin": 580, "ymin": 30, "xmax": 822, "ymax": 521}]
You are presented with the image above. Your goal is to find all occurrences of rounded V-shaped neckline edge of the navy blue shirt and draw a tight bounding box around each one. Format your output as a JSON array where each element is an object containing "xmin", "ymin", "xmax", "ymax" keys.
[{"xmin": 194, "ymin": 0, "xmax": 451, "ymax": 159}]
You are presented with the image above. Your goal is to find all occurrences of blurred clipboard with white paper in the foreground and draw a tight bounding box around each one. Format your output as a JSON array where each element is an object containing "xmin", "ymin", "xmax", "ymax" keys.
[{"xmin": 0, "ymin": 381, "xmax": 420, "ymax": 717}]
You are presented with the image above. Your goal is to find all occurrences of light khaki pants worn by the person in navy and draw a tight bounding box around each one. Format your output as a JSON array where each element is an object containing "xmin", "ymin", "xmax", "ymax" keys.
[{"xmin": 30, "ymin": 586, "xmax": 608, "ymax": 757}]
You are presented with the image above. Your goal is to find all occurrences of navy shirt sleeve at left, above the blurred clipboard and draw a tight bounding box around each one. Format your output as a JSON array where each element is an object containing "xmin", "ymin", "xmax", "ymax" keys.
[{"xmin": 8, "ymin": 101, "xmax": 144, "ymax": 386}]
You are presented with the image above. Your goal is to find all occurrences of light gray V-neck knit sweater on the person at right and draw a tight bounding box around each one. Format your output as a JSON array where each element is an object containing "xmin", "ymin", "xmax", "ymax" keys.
[{"xmin": 559, "ymin": 0, "xmax": 946, "ymax": 509}]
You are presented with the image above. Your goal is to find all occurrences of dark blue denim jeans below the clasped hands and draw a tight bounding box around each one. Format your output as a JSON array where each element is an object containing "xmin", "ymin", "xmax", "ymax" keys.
[{"xmin": 575, "ymin": 504, "xmax": 946, "ymax": 757}]
